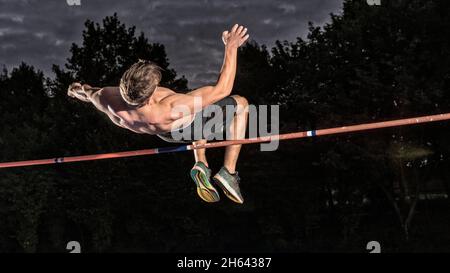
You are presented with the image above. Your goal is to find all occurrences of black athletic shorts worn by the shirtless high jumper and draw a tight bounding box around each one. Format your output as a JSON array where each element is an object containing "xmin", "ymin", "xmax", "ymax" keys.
[{"xmin": 158, "ymin": 97, "xmax": 237, "ymax": 143}]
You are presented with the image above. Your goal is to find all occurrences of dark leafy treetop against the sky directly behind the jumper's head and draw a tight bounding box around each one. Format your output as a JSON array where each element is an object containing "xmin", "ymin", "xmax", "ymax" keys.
[{"xmin": 55, "ymin": 14, "xmax": 187, "ymax": 91}]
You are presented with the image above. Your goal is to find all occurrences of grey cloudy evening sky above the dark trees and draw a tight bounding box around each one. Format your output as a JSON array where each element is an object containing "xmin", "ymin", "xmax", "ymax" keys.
[{"xmin": 0, "ymin": 0, "xmax": 342, "ymax": 88}]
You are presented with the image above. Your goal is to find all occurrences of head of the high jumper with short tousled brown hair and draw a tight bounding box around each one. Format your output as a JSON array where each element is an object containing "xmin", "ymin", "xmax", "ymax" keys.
[{"xmin": 120, "ymin": 60, "xmax": 161, "ymax": 107}]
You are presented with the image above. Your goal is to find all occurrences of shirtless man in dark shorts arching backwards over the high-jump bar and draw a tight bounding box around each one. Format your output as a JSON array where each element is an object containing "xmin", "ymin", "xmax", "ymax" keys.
[{"xmin": 68, "ymin": 24, "xmax": 249, "ymax": 204}]
